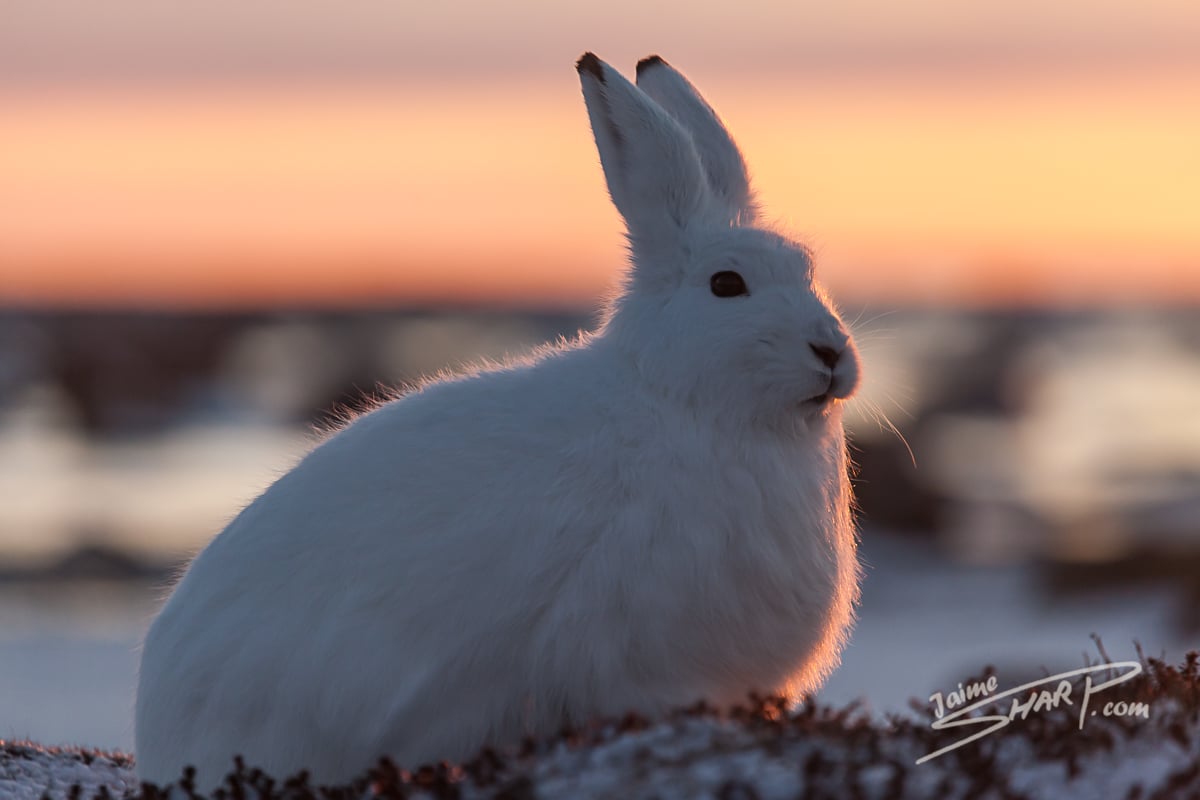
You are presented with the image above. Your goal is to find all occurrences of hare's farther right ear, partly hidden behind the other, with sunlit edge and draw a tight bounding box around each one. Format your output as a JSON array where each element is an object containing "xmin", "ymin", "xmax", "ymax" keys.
[{"xmin": 637, "ymin": 55, "xmax": 758, "ymax": 222}]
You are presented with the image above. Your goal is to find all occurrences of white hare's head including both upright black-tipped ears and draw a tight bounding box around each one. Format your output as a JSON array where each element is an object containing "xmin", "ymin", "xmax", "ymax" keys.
[{"xmin": 577, "ymin": 53, "xmax": 859, "ymax": 426}]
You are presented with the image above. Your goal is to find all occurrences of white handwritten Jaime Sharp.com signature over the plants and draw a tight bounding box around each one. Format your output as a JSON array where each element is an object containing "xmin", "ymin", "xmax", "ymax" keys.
[{"xmin": 917, "ymin": 661, "xmax": 1150, "ymax": 764}]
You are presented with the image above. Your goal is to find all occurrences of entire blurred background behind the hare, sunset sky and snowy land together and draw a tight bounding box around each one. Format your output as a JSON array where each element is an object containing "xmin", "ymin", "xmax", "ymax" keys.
[{"xmin": 0, "ymin": 0, "xmax": 1200, "ymax": 748}]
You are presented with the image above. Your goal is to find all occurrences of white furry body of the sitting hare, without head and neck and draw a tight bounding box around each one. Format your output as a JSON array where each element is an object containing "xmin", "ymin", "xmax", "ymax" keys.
[{"xmin": 138, "ymin": 335, "xmax": 857, "ymax": 781}]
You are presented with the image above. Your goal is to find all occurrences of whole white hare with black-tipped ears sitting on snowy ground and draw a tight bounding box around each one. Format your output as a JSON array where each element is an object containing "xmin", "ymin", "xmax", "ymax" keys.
[{"xmin": 137, "ymin": 54, "xmax": 859, "ymax": 786}]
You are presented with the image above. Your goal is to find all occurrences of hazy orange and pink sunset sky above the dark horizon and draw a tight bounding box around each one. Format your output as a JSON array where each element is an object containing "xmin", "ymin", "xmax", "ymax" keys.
[{"xmin": 0, "ymin": 0, "xmax": 1200, "ymax": 307}]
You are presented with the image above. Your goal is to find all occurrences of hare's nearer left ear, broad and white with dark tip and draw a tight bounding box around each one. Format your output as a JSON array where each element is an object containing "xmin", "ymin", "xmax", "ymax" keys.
[{"xmin": 575, "ymin": 53, "xmax": 715, "ymax": 262}]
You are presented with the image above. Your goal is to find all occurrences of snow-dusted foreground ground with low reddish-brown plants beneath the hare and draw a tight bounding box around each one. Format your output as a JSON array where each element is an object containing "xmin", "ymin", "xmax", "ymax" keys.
[{"xmin": 0, "ymin": 652, "xmax": 1200, "ymax": 800}]
